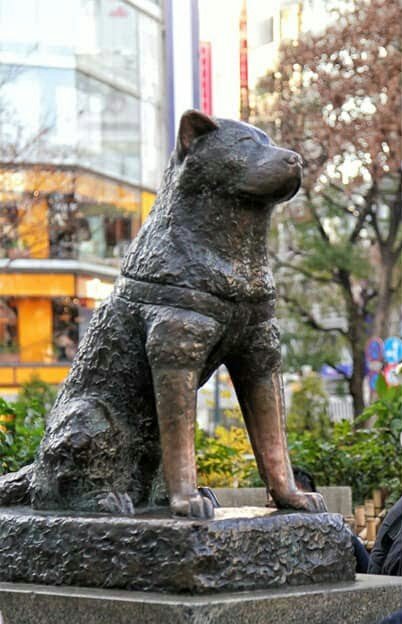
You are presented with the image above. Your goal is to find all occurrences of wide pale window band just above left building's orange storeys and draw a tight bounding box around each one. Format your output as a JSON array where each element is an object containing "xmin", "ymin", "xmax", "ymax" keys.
[{"xmin": 0, "ymin": 66, "xmax": 140, "ymax": 182}]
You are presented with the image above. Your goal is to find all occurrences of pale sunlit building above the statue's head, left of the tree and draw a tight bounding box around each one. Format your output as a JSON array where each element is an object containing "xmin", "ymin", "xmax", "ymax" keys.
[{"xmin": 199, "ymin": 0, "xmax": 331, "ymax": 119}]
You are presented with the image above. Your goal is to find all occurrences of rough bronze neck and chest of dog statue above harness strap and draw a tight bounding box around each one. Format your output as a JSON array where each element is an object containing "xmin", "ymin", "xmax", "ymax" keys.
[{"xmin": 122, "ymin": 205, "xmax": 274, "ymax": 301}]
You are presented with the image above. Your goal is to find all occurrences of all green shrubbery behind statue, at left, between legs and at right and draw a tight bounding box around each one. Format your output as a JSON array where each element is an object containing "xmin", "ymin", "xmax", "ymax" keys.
[{"xmin": 0, "ymin": 376, "xmax": 402, "ymax": 505}]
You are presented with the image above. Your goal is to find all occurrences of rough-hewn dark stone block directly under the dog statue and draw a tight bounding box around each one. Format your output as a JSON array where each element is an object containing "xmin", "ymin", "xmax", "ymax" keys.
[{"xmin": 0, "ymin": 508, "xmax": 355, "ymax": 594}]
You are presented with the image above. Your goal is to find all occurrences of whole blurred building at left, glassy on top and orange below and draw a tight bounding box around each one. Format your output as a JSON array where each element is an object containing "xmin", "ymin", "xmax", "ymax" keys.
[{"xmin": 0, "ymin": 0, "xmax": 168, "ymax": 391}]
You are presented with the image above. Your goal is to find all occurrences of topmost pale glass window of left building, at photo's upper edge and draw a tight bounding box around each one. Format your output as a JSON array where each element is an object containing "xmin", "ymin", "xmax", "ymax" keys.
[{"xmin": 77, "ymin": 0, "xmax": 138, "ymax": 87}]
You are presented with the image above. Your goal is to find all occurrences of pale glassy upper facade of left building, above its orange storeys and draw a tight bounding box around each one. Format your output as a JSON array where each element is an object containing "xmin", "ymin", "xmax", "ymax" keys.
[{"xmin": 0, "ymin": 0, "xmax": 166, "ymax": 189}]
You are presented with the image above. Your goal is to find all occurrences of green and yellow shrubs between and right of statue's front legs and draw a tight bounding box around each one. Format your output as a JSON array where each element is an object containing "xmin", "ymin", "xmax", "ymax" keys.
[{"xmin": 197, "ymin": 381, "xmax": 402, "ymax": 506}]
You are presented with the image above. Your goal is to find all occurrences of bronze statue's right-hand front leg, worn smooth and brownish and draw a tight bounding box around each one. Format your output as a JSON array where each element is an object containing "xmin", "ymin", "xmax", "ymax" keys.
[{"xmin": 226, "ymin": 321, "xmax": 326, "ymax": 511}]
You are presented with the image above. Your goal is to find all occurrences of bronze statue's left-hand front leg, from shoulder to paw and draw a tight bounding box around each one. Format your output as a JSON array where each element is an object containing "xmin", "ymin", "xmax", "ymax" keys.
[{"xmin": 146, "ymin": 308, "xmax": 221, "ymax": 518}]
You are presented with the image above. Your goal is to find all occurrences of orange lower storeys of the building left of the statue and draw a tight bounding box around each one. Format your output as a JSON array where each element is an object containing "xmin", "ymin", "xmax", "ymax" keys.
[{"xmin": 0, "ymin": 165, "xmax": 147, "ymax": 387}]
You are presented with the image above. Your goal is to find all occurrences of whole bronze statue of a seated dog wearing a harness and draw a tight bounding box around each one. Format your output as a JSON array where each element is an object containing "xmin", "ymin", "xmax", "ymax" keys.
[{"xmin": 0, "ymin": 111, "xmax": 325, "ymax": 518}]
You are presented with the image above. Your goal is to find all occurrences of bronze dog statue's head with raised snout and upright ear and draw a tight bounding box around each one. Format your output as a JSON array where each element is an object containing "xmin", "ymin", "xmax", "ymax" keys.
[{"xmin": 175, "ymin": 110, "xmax": 302, "ymax": 204}]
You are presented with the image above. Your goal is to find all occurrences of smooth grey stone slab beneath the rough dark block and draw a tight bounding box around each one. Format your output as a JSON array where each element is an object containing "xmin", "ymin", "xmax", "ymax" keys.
[{"xmin": 0, "ymin": 574, "xmax": 402, "ymax": 624}]
